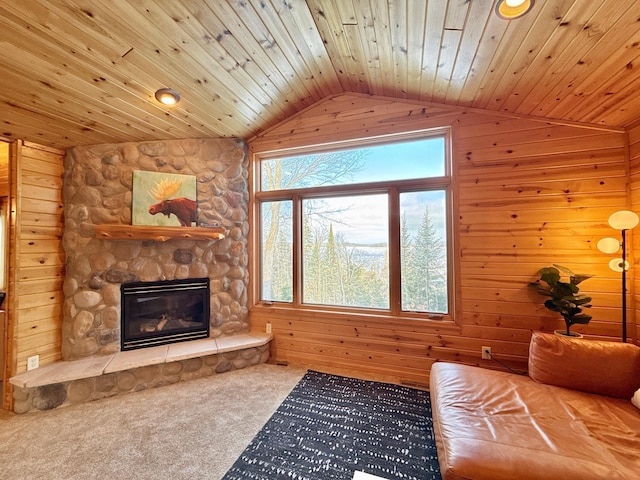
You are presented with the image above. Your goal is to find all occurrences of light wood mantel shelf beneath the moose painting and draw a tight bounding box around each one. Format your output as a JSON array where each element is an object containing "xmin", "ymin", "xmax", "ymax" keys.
[{"xmin": 95, "ymin": 224, "xmax": 226, "ymax": 242}]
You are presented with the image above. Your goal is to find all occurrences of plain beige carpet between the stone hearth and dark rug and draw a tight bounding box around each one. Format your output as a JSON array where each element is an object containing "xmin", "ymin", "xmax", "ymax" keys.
[{"xmin": 0, "ymin": 364, "xmax": 305, "ymax": 480}]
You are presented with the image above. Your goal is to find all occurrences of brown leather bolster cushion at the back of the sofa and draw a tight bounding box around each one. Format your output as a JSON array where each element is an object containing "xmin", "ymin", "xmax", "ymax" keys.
[{"xmin": 529, "ymin": 332, "xmax": 640, "ymax": 399}]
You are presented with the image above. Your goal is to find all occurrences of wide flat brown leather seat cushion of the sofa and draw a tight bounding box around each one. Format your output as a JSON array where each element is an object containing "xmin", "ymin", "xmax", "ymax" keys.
[{"xmin": 430, "ymin": 363, "xmax": 640, "ymax": 480}]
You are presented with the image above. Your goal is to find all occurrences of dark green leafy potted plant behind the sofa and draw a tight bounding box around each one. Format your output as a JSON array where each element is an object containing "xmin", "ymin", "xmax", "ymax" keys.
[{"xmin": 529, "ymin": 264, "xmax": 592, "ymax": 337}]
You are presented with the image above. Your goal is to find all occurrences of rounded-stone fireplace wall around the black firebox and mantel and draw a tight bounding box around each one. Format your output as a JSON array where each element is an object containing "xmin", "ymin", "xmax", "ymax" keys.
[{"xmin": 62, "ymin": 138, "xmax": 249, "ymax": 358}]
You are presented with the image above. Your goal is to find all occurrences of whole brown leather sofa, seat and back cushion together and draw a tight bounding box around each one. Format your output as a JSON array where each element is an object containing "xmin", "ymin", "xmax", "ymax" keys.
[{"xmin": 430, "ymin": 332, "xmax": 640, "ymax": 480}]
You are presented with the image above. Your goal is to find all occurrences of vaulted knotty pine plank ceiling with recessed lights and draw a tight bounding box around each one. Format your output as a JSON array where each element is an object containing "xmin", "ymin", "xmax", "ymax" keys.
[{"xmin": 0, "ymin": 0, "xmax": 640, "ymax": 148}]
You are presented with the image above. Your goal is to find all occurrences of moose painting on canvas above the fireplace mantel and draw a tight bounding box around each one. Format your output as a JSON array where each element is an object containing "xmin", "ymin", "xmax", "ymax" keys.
[{"xmin": 132, "ymin": 170, "xmax": 196, "ymax": 227}]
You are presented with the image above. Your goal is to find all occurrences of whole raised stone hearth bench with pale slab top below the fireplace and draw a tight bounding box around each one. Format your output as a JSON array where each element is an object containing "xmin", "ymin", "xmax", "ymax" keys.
[{"xmin": 9, "ymin": 332, "xmax": 273, "ymax": 413}]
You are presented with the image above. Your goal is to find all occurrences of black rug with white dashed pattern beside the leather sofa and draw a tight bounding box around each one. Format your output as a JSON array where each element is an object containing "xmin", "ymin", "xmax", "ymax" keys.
[{"xmin": 223, "ymin": 371, "xmax": 441, "ymax": 480}]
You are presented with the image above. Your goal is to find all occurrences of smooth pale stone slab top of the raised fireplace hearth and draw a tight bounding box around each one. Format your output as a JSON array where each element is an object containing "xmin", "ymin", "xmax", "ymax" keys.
[{"xmin": 9, "ymin": 332, "xmax": 273, "ymax": 388}]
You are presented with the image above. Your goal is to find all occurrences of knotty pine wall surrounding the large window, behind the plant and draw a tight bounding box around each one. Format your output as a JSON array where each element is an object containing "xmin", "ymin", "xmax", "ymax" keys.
[{"xmin": 249, "ymin": 94, "xmax": 628, "ymax": 385}]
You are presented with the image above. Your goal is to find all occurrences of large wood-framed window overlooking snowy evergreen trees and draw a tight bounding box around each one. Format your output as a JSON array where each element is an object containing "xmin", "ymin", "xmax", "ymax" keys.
[{"xmin": 254, "ymin": 132, "xmax": 452, "ymax": 317}]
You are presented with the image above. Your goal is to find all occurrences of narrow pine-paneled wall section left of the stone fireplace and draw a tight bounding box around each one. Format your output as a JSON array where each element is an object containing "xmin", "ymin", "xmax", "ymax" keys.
[{"xmin": 3, "ymin": 142, "xmax": 64, "ymax": 408}]
